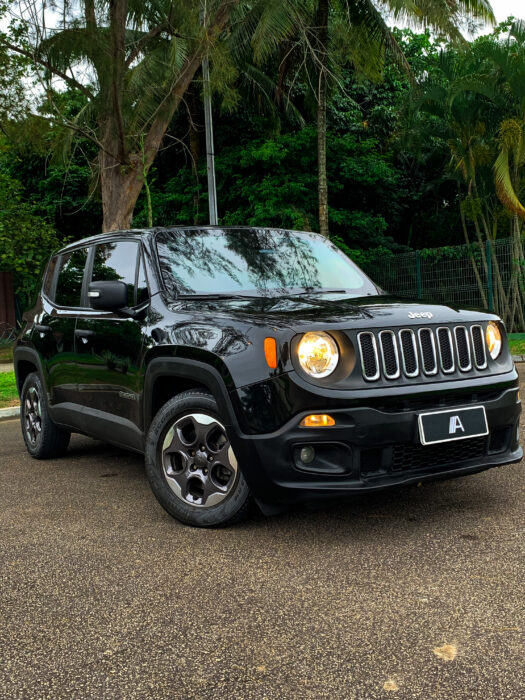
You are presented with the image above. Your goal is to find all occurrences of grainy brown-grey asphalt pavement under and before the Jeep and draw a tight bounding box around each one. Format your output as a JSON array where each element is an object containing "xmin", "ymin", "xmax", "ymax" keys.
[{"xmin": 0, "ymin": 370, "xmax": 525, "ymax": 700}]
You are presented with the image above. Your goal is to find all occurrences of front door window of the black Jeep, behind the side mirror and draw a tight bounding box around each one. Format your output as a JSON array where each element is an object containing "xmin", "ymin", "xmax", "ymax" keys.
[{"xmin": 91, "ymin": 241, "xmax": 139, "ymax": 306}]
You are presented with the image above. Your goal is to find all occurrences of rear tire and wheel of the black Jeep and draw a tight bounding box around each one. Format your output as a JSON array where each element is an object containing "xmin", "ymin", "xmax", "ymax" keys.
[{"xmin": 20, "ymin": 372, "xmax": 71, "ymax": 459}]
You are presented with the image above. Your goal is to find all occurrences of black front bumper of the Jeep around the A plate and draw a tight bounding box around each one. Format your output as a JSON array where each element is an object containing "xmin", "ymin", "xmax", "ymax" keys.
[{"xmin": 232, "ymin": 374, "xmax": 523, "ymax": 504}]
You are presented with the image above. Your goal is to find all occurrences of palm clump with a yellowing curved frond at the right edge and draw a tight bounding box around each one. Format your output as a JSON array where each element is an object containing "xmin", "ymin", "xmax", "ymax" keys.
[{"xmin": 414, "ymin": 22, "xmax": 525, "ymax": 330}]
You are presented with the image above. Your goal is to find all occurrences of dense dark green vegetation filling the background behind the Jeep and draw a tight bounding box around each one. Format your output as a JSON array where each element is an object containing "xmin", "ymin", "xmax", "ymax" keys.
[{"xmin": 0, "ymin": 5, "xmax": 525, "ymax": 322}]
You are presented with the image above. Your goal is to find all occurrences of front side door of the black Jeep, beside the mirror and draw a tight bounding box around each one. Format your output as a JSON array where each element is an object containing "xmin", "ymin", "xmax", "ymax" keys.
[{"xmin": 75, "ymin": 240, "xmax": 149, "ymax": 442}]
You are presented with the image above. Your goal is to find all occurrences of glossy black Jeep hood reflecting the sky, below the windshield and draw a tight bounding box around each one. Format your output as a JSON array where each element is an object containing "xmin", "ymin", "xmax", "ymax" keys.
[{"xmin": 170, "ymin": 294, "xmax": 496, "ymax": 332}]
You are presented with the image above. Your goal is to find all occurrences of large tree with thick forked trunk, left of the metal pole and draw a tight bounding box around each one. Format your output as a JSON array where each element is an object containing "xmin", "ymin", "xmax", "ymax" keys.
[{"xmin": 0, "ymin": 0, "xmax": 300, "ymax": 231}]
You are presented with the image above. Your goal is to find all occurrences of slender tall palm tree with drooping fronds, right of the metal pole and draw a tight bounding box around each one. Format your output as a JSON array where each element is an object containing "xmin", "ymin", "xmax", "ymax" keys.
[{"xmin": 252, "ymin": 0, "xmax": 494, "ymax": 235}]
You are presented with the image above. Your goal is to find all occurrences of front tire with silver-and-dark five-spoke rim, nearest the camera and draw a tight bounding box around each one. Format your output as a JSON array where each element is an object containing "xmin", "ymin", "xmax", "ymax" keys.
[{"xmin": 145, "ymin": 389, "xmax": 251, "ymax": 527}]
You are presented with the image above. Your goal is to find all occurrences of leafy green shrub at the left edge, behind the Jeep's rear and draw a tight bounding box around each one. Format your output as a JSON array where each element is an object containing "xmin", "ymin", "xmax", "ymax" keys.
[{"xmin": 0, "ymin": 172, "xmax": 60, "ymax": 305}]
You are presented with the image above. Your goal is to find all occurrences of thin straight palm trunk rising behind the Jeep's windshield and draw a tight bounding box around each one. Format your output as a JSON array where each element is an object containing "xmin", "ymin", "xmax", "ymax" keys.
[{"xmin": 316, "ymin": 0, "xmax": 330, "ymax": 237}]
